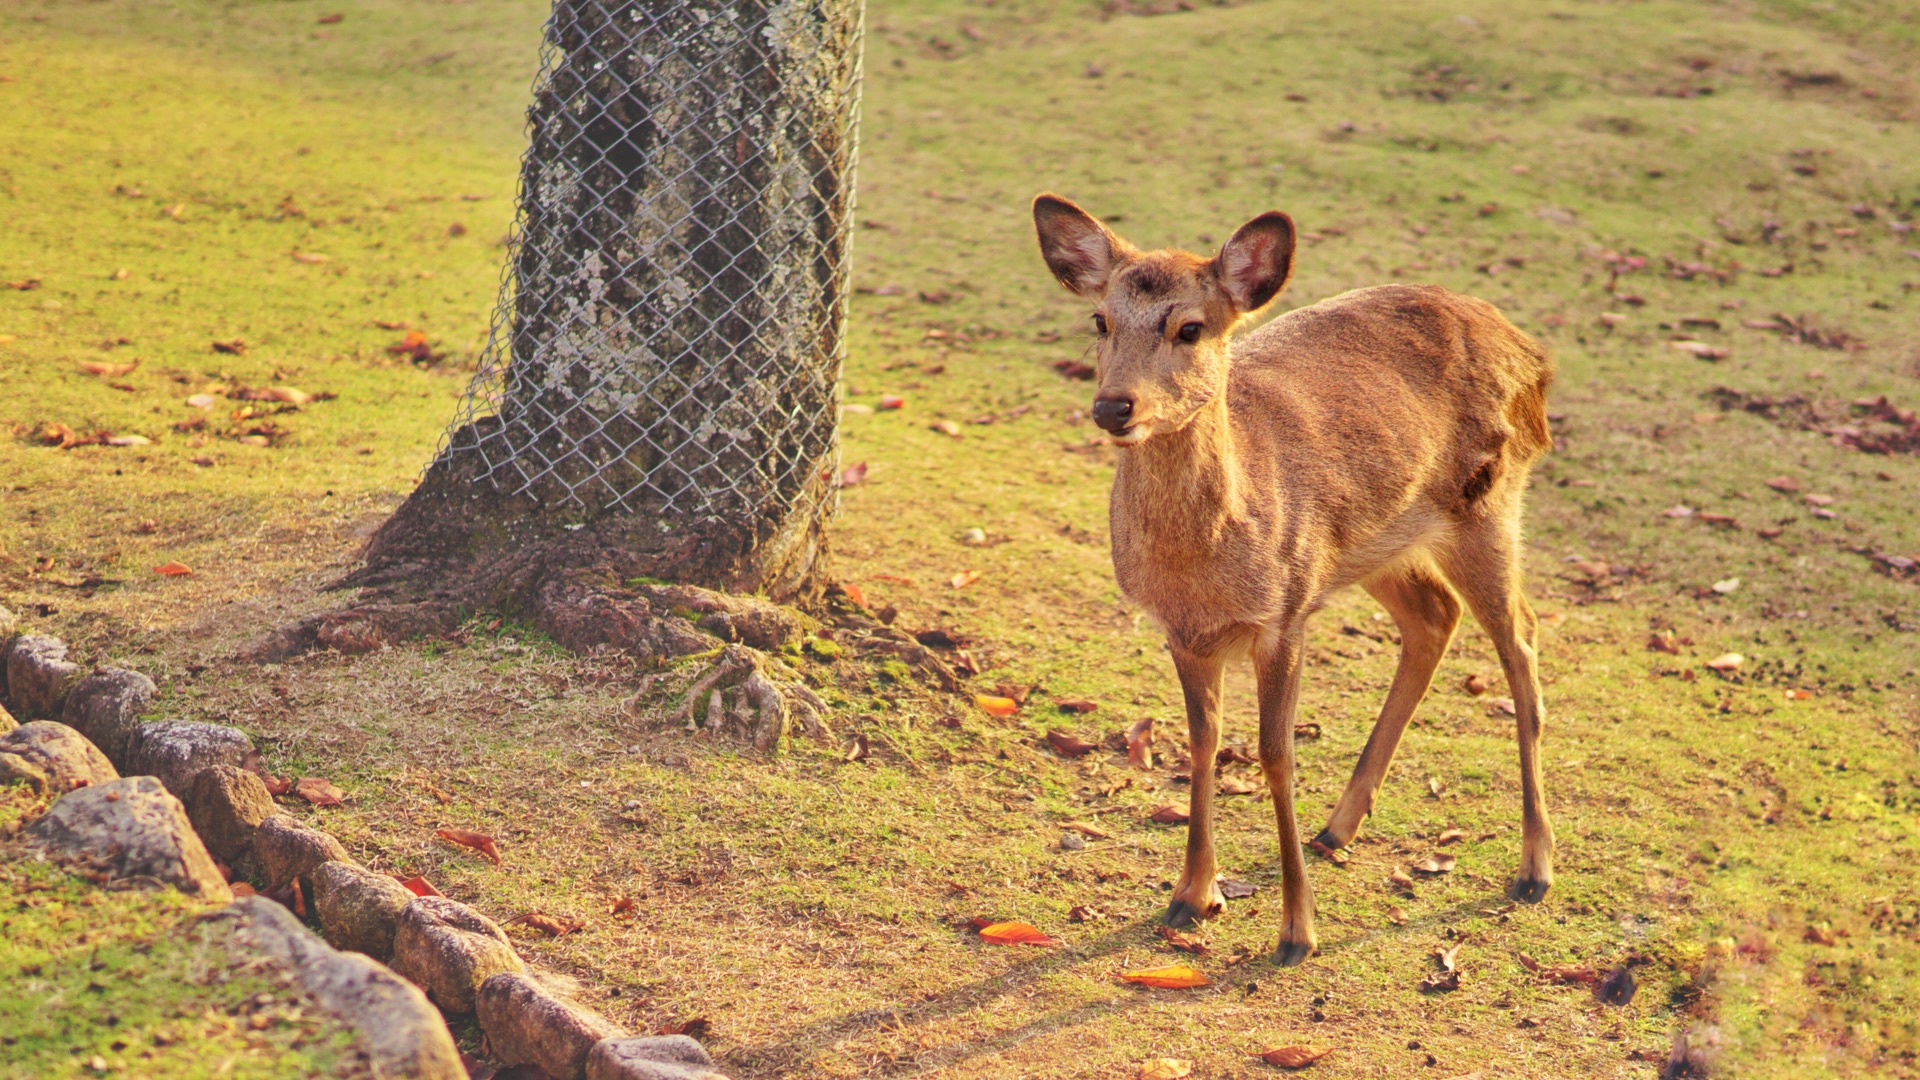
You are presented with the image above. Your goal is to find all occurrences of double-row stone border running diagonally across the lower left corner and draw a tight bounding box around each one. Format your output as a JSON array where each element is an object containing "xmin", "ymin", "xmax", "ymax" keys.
[{"xmin": 0, "ymin": 607, "xmax": 726, "ymax": 1080}]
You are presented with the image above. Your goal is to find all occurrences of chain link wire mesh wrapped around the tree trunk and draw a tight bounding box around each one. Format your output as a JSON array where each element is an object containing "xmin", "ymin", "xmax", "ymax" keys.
[{"xmin": 440, "ymin": 0, "xmax": 862, "ymax": 521}]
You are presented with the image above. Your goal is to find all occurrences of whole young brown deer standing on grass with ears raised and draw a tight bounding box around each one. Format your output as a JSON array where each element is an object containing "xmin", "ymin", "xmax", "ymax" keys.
[{"xmin": 1033, "ymin": 194, "xmax": 1553, "ymax": 965}]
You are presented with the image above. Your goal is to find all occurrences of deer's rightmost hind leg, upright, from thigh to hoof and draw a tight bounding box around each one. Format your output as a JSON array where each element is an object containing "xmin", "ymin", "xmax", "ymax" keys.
[{"xmin": 1440, "ymin": 511, "xmax": 1553, "ymax": 903}]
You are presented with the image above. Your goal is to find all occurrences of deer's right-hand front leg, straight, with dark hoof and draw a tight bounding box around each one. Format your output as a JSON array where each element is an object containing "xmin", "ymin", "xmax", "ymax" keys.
[{"xmin": 1254, "ymin": 632, "xmax": 1315, "ymax": 967}]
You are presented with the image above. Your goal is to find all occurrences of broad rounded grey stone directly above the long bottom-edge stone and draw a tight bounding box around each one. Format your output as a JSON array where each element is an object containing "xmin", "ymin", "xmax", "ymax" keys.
[{"xmin": 25, "ymin": 776, "xmax": 232, "ymax": 903}]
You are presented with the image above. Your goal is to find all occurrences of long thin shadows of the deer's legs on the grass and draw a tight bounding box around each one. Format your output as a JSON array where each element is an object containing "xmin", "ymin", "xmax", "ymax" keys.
[{"xmin": 730, "ymin": 890, "xmax": 1509, "ymax": 1074}]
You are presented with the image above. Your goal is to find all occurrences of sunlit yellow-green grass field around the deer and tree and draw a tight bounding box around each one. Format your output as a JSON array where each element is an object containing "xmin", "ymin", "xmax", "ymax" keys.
[{"xmin": 0, "ymin": 0, "xmax": 1920, "ymax": 1078}]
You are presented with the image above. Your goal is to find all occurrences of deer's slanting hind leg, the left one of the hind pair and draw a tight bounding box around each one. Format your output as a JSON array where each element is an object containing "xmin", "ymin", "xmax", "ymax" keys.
[{"xmin": 1313, "ymin": 561, "xmax": 1459, "ymax": 847}]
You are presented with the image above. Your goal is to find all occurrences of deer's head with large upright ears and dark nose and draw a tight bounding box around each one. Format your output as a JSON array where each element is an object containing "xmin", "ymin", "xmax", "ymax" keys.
[{"xmin": 1033, "ymin": 194, "xmax": 1294, "ymax": 446}]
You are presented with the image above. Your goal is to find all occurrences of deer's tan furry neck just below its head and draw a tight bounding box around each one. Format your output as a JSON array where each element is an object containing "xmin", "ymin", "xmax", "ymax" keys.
[{"xmin": 1114, "ymin": 386, "xmax": 1246, "ymax": 534}]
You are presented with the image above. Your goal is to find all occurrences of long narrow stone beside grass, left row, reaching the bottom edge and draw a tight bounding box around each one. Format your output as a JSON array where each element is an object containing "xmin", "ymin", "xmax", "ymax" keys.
[{"xmin": 211, "ymin": 896, "xmax": 467, "ymax": 1080}]
